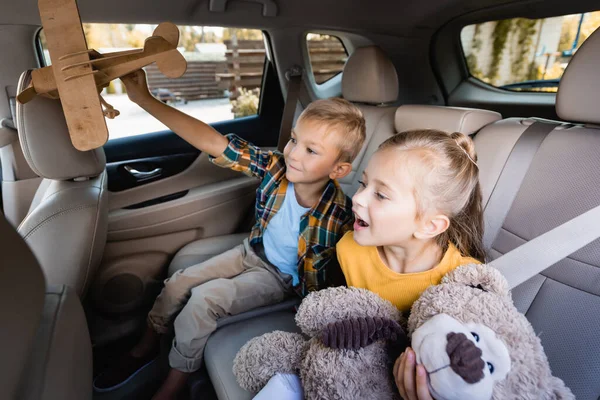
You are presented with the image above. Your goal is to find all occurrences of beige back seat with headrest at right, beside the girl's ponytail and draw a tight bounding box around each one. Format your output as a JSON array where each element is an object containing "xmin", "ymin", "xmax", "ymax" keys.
[{"xmin": 475, "ymin": 26, "xmax": 600, "ymax": 400}]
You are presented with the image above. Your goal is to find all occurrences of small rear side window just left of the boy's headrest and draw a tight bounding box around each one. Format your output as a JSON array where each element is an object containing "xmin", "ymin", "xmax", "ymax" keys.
[{"xmin": 306, "ymin": 33, "xmax": 348, "ymax": 85}]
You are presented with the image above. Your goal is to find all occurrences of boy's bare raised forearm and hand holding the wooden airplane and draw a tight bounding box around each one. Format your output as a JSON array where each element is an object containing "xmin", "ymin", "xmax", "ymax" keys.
[{"xmin": 121, "ymin": 70, "xmax": 229, "ymax": 157}]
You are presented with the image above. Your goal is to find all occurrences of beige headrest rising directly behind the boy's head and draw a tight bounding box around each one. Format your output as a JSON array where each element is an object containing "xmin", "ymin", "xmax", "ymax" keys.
[{"xmin": 342, "ymin": 46, "xmax": 398, "ymax": 104}]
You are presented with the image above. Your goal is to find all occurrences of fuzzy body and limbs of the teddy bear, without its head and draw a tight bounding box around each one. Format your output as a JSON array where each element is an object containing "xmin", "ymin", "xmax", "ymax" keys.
[{"xmin": 233, "ymin": 287, "xmax": 408, "ymax": 400}]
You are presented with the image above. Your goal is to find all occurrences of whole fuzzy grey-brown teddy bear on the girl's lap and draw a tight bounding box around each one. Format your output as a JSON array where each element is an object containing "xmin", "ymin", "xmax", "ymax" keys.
[{"xmin": 234, "ymin": 264, "xmax": 575, "ymax": 400}]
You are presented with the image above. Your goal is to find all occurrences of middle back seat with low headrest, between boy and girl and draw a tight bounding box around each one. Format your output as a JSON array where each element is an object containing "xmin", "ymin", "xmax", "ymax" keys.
[{"xmin": 204, "ymin": 105, "xmax": 501, "ymax": 400}]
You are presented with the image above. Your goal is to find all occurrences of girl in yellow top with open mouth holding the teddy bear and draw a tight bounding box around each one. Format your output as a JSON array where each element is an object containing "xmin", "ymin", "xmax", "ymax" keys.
[{"xmin": 255, "ymin": 130, "xmax": 485, "ymax": 400}]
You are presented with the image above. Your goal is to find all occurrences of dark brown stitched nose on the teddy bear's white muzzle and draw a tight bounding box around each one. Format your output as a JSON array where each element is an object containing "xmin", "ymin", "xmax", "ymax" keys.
[{"xmin": 446, "ymin": 332, "xmax": 485, "ymax": 384}]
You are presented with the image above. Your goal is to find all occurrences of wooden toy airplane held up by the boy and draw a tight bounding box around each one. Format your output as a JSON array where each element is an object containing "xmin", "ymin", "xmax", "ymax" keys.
[{"xmin": 17, "ymin": 0, "xmax": 187, "ymax": 151}]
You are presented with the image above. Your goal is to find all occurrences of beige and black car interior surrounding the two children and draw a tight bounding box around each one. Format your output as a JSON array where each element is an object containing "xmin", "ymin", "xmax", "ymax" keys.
[{"xmin": 0, "ymin": 0, "xmax": 600, "ymax": 400}]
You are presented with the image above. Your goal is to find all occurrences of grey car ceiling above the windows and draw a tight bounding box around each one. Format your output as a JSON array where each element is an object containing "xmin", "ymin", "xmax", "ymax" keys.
[{"xmin": 0, "ymin": 0, "xmax": 598, "ymax": 38}]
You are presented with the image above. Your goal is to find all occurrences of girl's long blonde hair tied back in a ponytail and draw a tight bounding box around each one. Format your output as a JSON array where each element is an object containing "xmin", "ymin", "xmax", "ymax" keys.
[{"xmin": 378, "ymin": 129, "xmax": 485, "ymax": 261}]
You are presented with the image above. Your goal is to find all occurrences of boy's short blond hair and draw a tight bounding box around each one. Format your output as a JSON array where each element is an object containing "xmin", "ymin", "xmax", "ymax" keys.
[{"xmin": 298, "ymin": 97, "xmax": 366, "ymax": 162}]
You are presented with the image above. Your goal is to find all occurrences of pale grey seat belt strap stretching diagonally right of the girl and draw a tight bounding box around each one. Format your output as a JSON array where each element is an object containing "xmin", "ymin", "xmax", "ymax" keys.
[{"xmin": 488, "ymin": 205, "xmax": 600, "ymax": 289}]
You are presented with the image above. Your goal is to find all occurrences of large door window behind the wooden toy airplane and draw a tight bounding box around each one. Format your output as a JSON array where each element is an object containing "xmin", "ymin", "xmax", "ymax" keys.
[{"xmin": 39, "ymin": 24, "xmax": 265, "ymax": 139}]
